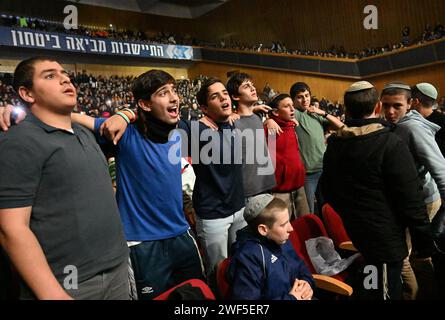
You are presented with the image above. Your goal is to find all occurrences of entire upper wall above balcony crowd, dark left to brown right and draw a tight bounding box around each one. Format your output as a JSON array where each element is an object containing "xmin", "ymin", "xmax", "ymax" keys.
[{"xmin": 0, "ymin": 0, "xmax": 445, "ymax": 52}]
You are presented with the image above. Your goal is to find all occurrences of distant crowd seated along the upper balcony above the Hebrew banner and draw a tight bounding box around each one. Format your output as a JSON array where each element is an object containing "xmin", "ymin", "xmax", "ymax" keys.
[{"xmin": 0, "ymin": 14, "xmax": 445, "ymax": 59}]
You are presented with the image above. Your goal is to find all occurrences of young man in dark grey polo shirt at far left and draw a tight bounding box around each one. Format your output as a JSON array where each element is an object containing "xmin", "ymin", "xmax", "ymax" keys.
[{"xmin": 0, "ymin": 57, "xmax": 129, "ymax": 299}]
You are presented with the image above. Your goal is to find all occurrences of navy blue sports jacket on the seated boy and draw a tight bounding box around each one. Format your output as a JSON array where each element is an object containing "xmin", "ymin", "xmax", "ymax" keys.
[{"xmin": 227, "ymin": 227, "xmax": 314, "ymax": 300}]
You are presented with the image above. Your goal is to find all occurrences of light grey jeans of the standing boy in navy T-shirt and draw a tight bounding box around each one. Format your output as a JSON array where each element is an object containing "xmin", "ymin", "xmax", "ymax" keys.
[{"xmin": 196, "ymin": 208, "xmax": 247, "ymax": 278}]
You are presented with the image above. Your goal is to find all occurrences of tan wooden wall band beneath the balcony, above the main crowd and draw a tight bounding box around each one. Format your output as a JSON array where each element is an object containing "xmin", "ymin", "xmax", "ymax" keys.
[{"xmin": 0, "ymin": 59, "xmax": 445, "ymax": 101}]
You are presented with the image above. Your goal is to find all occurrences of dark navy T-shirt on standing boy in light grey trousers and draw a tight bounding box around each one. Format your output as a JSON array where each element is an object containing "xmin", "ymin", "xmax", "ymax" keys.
[{"xmin": 179, "ymin": 120, "xmax": 245, "ymax": 219}]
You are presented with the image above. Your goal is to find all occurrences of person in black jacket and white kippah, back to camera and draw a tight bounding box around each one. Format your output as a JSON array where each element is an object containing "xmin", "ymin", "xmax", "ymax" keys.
[{"xmin": 320, "ymin": 81, "xmax": 433, "ymax": 300}]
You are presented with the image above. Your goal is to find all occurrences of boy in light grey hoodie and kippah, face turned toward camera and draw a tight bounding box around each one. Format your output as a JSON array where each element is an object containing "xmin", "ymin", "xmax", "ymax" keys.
[{"xmin": 381, "ymin": 82, "xmax": 445, "ymax": 299}]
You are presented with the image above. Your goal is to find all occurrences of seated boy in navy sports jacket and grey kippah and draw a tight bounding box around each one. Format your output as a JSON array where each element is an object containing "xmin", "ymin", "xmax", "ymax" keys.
[{"xmin": 228, "ymin": 194, "xmax": 314, "ymax": 300}]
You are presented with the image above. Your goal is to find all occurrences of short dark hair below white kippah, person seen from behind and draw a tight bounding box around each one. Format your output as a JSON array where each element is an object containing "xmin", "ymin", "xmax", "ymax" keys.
[{"xmin": 344, "ymin": 88, "xmax": 379, "ymax": 119}]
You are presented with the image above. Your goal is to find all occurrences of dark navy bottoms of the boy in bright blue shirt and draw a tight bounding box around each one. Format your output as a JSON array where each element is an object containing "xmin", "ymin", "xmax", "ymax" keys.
[{"xmin": 130, "ymin": 231, "xmax": 204, "ymax": 300}]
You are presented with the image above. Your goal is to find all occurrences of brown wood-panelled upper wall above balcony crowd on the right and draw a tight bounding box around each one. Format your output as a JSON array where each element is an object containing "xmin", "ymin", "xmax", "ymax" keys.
[{"xmin": 195, "ymin": 0, "xmax": 445, "ymax": 51}]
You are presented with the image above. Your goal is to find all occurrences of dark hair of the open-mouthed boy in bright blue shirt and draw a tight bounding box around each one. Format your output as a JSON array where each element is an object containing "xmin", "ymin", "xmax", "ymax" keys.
[{"xmin": 131, "ymin": 69, "xmax": 175, "ymax": 103}]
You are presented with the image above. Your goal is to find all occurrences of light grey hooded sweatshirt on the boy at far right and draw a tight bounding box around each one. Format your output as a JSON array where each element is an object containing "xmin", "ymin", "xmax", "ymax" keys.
[{"xmin": 394, "ymin": 110, "xmax": 445, "ymax": 204}]
